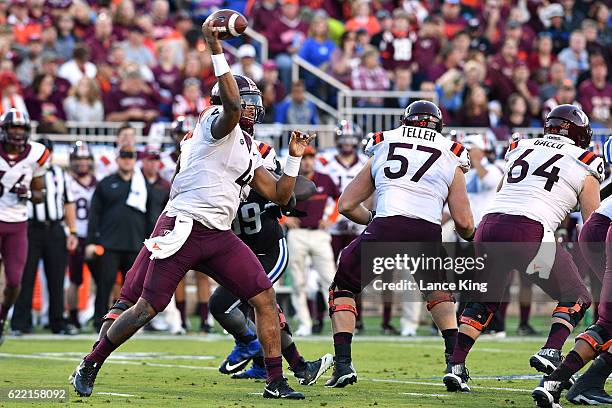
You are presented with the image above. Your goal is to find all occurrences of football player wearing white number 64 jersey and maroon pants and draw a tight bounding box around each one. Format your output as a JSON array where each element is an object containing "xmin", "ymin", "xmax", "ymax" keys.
[{"xmin": 444, "ymin": 105, "xmax": 604, "ymax": 391}]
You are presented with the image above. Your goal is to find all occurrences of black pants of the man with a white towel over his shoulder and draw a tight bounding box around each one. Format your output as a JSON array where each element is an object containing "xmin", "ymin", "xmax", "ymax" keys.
[{"xmin": 91, "ymin": 249, "xmax": 138, "ymax": 330}]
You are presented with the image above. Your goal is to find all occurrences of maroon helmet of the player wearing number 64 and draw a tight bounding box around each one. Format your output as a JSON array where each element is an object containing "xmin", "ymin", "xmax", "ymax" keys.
[{"xmin": 544, "ymin": 104, "xmax": 593, "ymax": 149}]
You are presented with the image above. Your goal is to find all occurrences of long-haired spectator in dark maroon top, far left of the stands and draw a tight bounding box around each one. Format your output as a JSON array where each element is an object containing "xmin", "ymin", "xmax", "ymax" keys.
[{"xmin": 26, "ymin": 74, "xmax": 66, "ymax": 133}]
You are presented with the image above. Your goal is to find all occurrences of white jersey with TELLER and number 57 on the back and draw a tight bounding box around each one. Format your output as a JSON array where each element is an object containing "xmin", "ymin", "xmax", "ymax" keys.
[{"xmin": 366, "ymin": 126, "xmax": 470, "ymax": 224}]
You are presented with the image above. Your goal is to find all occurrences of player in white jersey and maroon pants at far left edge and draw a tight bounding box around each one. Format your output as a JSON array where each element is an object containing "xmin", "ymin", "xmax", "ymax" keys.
[{"xmin": 0, "ymin": 108, "xmax": 50, "ymax": 344}]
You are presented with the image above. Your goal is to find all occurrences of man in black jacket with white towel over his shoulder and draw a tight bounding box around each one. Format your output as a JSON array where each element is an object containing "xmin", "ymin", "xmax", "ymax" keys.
[{"xmin": 85, "ymin": 145, "xmax": 149, "ymax": 330}]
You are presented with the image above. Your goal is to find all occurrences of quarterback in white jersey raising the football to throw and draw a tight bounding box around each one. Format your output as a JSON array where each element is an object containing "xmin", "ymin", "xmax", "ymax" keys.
[{"xmin": 71, "ymin": 20, "xmax": 314, "ymax": 399}]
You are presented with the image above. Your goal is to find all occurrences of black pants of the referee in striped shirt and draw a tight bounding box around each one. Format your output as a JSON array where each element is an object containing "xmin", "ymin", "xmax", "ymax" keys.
[{"xmin": 11, "ymin": 222, "xmax": 68, "ymax": 332}]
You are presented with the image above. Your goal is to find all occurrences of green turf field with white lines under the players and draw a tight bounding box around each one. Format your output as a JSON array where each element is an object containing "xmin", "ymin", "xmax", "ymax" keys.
[{"xmin": 0, "ymin": 328, "xmax": 572, "ymax": 408}]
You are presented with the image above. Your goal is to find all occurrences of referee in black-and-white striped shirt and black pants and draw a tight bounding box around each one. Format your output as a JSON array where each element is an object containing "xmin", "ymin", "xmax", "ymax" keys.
[{"xmin": 11, "ymin": 139, "xmax": 78, "ymax": 335}]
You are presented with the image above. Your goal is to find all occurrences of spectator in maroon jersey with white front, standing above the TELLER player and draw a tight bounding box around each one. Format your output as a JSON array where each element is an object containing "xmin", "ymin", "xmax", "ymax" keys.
[{"xmin": 378, "ymin": 9, "xmax": 417, "ymax": 71}]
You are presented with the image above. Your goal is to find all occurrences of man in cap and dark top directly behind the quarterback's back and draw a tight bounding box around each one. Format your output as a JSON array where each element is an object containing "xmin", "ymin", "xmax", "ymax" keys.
[{"xmin": 142, "ymin": 147, "xmax": 171, "ymax": 237}]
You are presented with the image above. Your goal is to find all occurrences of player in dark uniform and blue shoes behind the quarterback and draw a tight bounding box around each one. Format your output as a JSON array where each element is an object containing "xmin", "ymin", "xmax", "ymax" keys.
[{"xmin": 210, "ymin": 123, "xmax": 333, "ymax": 385}]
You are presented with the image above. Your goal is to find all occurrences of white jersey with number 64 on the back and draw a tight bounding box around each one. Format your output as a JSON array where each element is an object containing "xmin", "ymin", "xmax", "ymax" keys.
[{"xmin": 487, "ymin": 136, "xmax": 604, "ymax": 231}]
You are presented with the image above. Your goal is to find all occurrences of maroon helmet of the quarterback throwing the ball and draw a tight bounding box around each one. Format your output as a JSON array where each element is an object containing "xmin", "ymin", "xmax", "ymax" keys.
[{"xmin": 210, "ymin": 75, "xmax": 266, "ymax": 136}]
